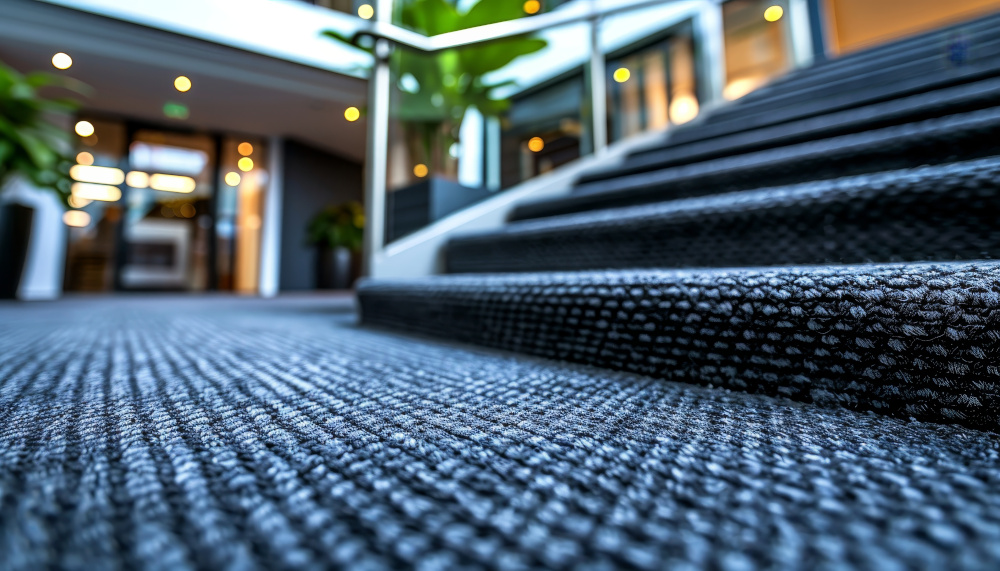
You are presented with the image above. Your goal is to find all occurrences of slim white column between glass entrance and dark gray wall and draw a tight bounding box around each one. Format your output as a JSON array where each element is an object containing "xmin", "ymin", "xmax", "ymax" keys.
[{"xmin": 259, "ymin": 137, "xmax": 285, "ymax": 297}]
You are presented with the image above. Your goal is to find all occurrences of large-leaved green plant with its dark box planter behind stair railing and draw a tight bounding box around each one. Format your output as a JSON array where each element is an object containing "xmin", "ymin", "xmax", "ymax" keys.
[{"xmin": 325, "ymin": 0, "xmax": 548, "ymax": 241}]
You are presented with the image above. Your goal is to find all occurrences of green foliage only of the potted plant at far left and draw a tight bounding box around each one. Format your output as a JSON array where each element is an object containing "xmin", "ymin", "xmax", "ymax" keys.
[{"xmin": 0, "ymin": 62, "xmax": 82, "ymax": 205}]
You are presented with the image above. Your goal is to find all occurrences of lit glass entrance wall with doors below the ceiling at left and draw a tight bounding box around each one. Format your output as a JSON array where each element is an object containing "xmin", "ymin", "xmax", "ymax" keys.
[{"xmin": 65, "ymin": 117, "xmax": 267, "ymax": 293}]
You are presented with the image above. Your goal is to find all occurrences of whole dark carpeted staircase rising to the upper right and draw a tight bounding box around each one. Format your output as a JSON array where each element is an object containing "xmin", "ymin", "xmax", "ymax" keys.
[{"xmin": 358, "ymin": 11, "xmax": 1000, "ymax": 568}]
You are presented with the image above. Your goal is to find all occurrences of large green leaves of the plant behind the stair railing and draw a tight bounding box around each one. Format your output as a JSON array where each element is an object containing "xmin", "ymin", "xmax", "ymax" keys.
[{"xmin": 325, "ymin": 0, "xmax": 548, "ymax": 177}]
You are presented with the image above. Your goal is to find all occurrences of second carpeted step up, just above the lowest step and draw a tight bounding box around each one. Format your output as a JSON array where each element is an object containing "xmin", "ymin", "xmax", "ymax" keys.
[{"xmin": 445, "ymin": 157, "xmax": 1000, "ymax": 273}]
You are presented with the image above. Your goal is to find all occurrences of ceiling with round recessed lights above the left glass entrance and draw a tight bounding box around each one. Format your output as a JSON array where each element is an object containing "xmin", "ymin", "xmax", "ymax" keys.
[{"xmin": 0, "ymin": 0, "xmax": 367, "ymax": 161}]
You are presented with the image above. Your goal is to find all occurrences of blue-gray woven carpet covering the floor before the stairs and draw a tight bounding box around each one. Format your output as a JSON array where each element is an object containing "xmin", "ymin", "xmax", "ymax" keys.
[{"xmin": 0, "ymin": 297, "xmax": 1000, "ymax": 571}]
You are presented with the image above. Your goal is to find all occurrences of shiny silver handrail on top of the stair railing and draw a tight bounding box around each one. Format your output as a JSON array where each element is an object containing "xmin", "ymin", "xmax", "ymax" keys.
[{"xmin": 351, "ymin": 0, "xmax": 678, "ymax": 54}]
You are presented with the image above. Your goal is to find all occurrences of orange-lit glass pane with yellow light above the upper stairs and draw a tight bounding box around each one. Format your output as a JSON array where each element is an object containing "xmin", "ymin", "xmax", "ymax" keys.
[{"xmin": 722, "ymin": 0, "xmax": 793, "ymax": 100}]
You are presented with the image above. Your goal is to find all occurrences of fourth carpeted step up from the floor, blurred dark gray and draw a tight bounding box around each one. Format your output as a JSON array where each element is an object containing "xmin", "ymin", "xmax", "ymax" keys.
[{"xmin": 578, "ymin": 74, "xmax": 1000, "ymax": 185}]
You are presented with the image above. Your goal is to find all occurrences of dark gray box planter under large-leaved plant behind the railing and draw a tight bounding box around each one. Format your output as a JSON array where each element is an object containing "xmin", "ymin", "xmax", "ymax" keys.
[{"xmin": 385, "ymin": 177, "xmax": 493, "ymax": 243}]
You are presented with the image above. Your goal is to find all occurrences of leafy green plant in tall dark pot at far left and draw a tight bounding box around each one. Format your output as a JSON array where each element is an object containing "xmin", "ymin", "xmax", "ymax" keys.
[{"xmin": 0, "ymin": 62, "xmax": 75, "ymax": 299}]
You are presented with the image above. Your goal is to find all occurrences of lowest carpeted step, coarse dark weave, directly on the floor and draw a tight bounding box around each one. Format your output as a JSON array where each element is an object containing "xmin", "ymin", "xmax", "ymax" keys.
[{"xmin": 358, "ymin": 262, "xmax": 1000, "ymax": 431}]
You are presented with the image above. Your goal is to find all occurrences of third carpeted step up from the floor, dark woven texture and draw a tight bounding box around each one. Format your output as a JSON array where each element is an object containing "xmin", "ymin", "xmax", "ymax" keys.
[{"xmin": 511, "ymin": 107, "xmax": 1000, "ymax": 220}]
